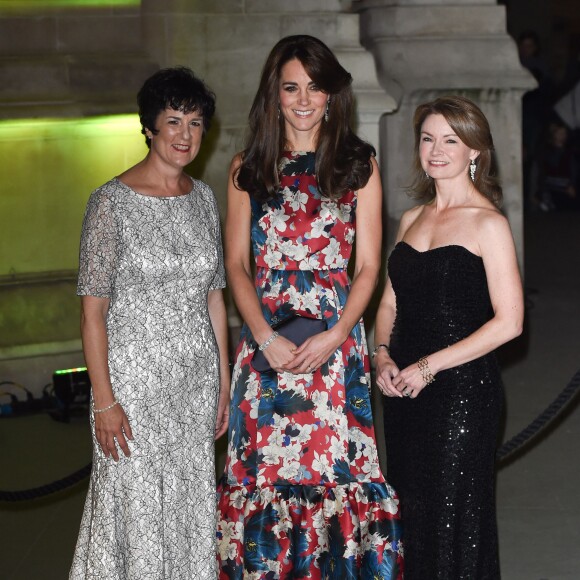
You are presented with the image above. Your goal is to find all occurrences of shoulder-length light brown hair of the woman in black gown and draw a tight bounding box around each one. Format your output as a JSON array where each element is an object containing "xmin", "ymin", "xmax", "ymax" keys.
[{"xmin": 409, "ymin": 96, "xmax": 503, "ymax": 208}]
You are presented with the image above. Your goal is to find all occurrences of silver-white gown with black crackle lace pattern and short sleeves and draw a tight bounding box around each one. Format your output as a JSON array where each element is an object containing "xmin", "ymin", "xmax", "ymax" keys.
[{"xmin": 70, "ymin": 179, "xmax": 225, "ymax": 580}]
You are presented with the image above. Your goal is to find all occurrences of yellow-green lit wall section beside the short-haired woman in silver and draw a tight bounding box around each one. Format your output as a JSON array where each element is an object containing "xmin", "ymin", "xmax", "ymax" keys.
[{"xmin": 0, "ymin": 114, "xmax": 147, "ymax": 276}]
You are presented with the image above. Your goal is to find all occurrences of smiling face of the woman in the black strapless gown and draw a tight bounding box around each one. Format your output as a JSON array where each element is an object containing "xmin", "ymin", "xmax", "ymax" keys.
[{"xmin": 419, "ymin": 115, "xmax": 478, "ymax": 184}]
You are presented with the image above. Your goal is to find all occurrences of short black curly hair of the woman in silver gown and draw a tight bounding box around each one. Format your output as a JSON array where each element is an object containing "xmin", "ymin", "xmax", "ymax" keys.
[{"xmin": 137, "ymin": 66, "xmax": 215, "ymax": 148}]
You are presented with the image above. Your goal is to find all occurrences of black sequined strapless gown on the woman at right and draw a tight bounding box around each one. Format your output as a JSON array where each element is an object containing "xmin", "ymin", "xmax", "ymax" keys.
[{"xmin": 384, "ymin": 242, "xmax": 503, "ymax": 580}]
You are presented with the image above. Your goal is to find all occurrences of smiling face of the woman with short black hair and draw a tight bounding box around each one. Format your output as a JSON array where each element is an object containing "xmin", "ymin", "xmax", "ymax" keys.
[{"xmin": 146, "ymin": 109, "xmax": 203, "ymax": 169}]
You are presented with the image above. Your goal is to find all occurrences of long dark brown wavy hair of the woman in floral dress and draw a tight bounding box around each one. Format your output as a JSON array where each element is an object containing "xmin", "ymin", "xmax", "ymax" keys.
[{"xmin": 233, "ymin": 35, "xmax": 376, "ymax": 201}]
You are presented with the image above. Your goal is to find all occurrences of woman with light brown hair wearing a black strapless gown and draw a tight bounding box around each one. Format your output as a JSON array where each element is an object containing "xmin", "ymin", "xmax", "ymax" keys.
[{"xmin": 374, "ymin": 97, "xmax": 523, "ymax": 580}]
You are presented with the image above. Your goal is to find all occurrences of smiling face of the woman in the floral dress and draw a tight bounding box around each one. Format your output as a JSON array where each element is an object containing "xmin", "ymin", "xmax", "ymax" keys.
[{"xmin": 278, "ymin": 59, "xmax": 328, "ymax": 149}]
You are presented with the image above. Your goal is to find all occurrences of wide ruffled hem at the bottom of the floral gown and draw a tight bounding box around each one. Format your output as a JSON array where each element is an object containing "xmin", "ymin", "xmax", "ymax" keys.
[{"xmin": 218, "ymin": 479, "xmax": 403, "ymax": 580}]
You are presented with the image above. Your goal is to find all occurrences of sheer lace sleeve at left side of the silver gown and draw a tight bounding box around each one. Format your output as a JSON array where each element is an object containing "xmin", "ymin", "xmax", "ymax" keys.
[{"xmin": 77, "ymin": 189, "xmax": 117, "ymax": 298}]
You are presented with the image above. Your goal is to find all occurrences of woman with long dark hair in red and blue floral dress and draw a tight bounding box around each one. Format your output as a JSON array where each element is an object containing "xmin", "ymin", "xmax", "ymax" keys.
[{"xmin": 218, "ymin": 36, "xmax": 402, "ymax": 579}]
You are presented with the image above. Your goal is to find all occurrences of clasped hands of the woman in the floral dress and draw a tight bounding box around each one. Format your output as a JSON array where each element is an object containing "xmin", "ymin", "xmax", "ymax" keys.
[{"xmin": 264, "ymin": 330, "xmax": 342, "ymax": 375}]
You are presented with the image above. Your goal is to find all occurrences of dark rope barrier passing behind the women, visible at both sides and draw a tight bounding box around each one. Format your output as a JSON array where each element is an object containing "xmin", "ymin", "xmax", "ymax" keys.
[{"xmin": 0, "ymin": 370, "xmax": 580, "ymax": 502}]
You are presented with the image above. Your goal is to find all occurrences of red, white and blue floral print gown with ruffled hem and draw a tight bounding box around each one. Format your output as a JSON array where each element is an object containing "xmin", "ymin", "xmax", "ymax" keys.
[{"xmin": 217, "ymin": 152, "xmax": 402, "ymax": 579}]
